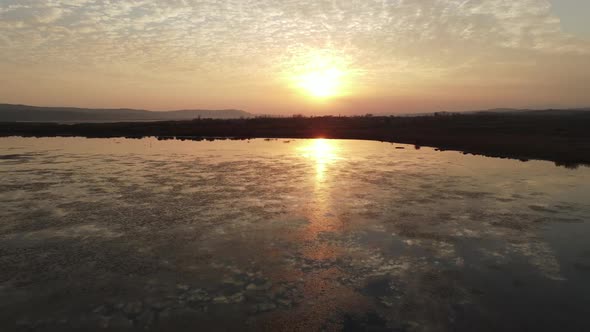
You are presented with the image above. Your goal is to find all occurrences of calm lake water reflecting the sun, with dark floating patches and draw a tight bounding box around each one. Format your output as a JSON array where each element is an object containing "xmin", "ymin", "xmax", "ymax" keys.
[{"xmin": 0, "ymin": 138, "xmax": 590, "ymax": 331}]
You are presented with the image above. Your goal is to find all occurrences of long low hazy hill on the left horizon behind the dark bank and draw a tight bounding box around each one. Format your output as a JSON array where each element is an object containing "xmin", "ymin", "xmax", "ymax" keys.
[{"xmin": 0, "ymin": 104, "xmax": 253, "ymax": 122}]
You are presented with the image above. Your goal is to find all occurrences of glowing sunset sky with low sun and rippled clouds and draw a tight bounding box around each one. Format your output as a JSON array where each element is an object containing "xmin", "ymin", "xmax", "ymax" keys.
[{"xmin": 0, "ymin": 0, "xmax": 590, "ymax": 115}]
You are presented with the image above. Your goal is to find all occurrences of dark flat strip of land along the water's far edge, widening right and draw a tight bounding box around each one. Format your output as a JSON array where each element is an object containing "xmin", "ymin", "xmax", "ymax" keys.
[{"xmin": 0, "ymin": 111, "xmax": 590, "ymax": 167}]
